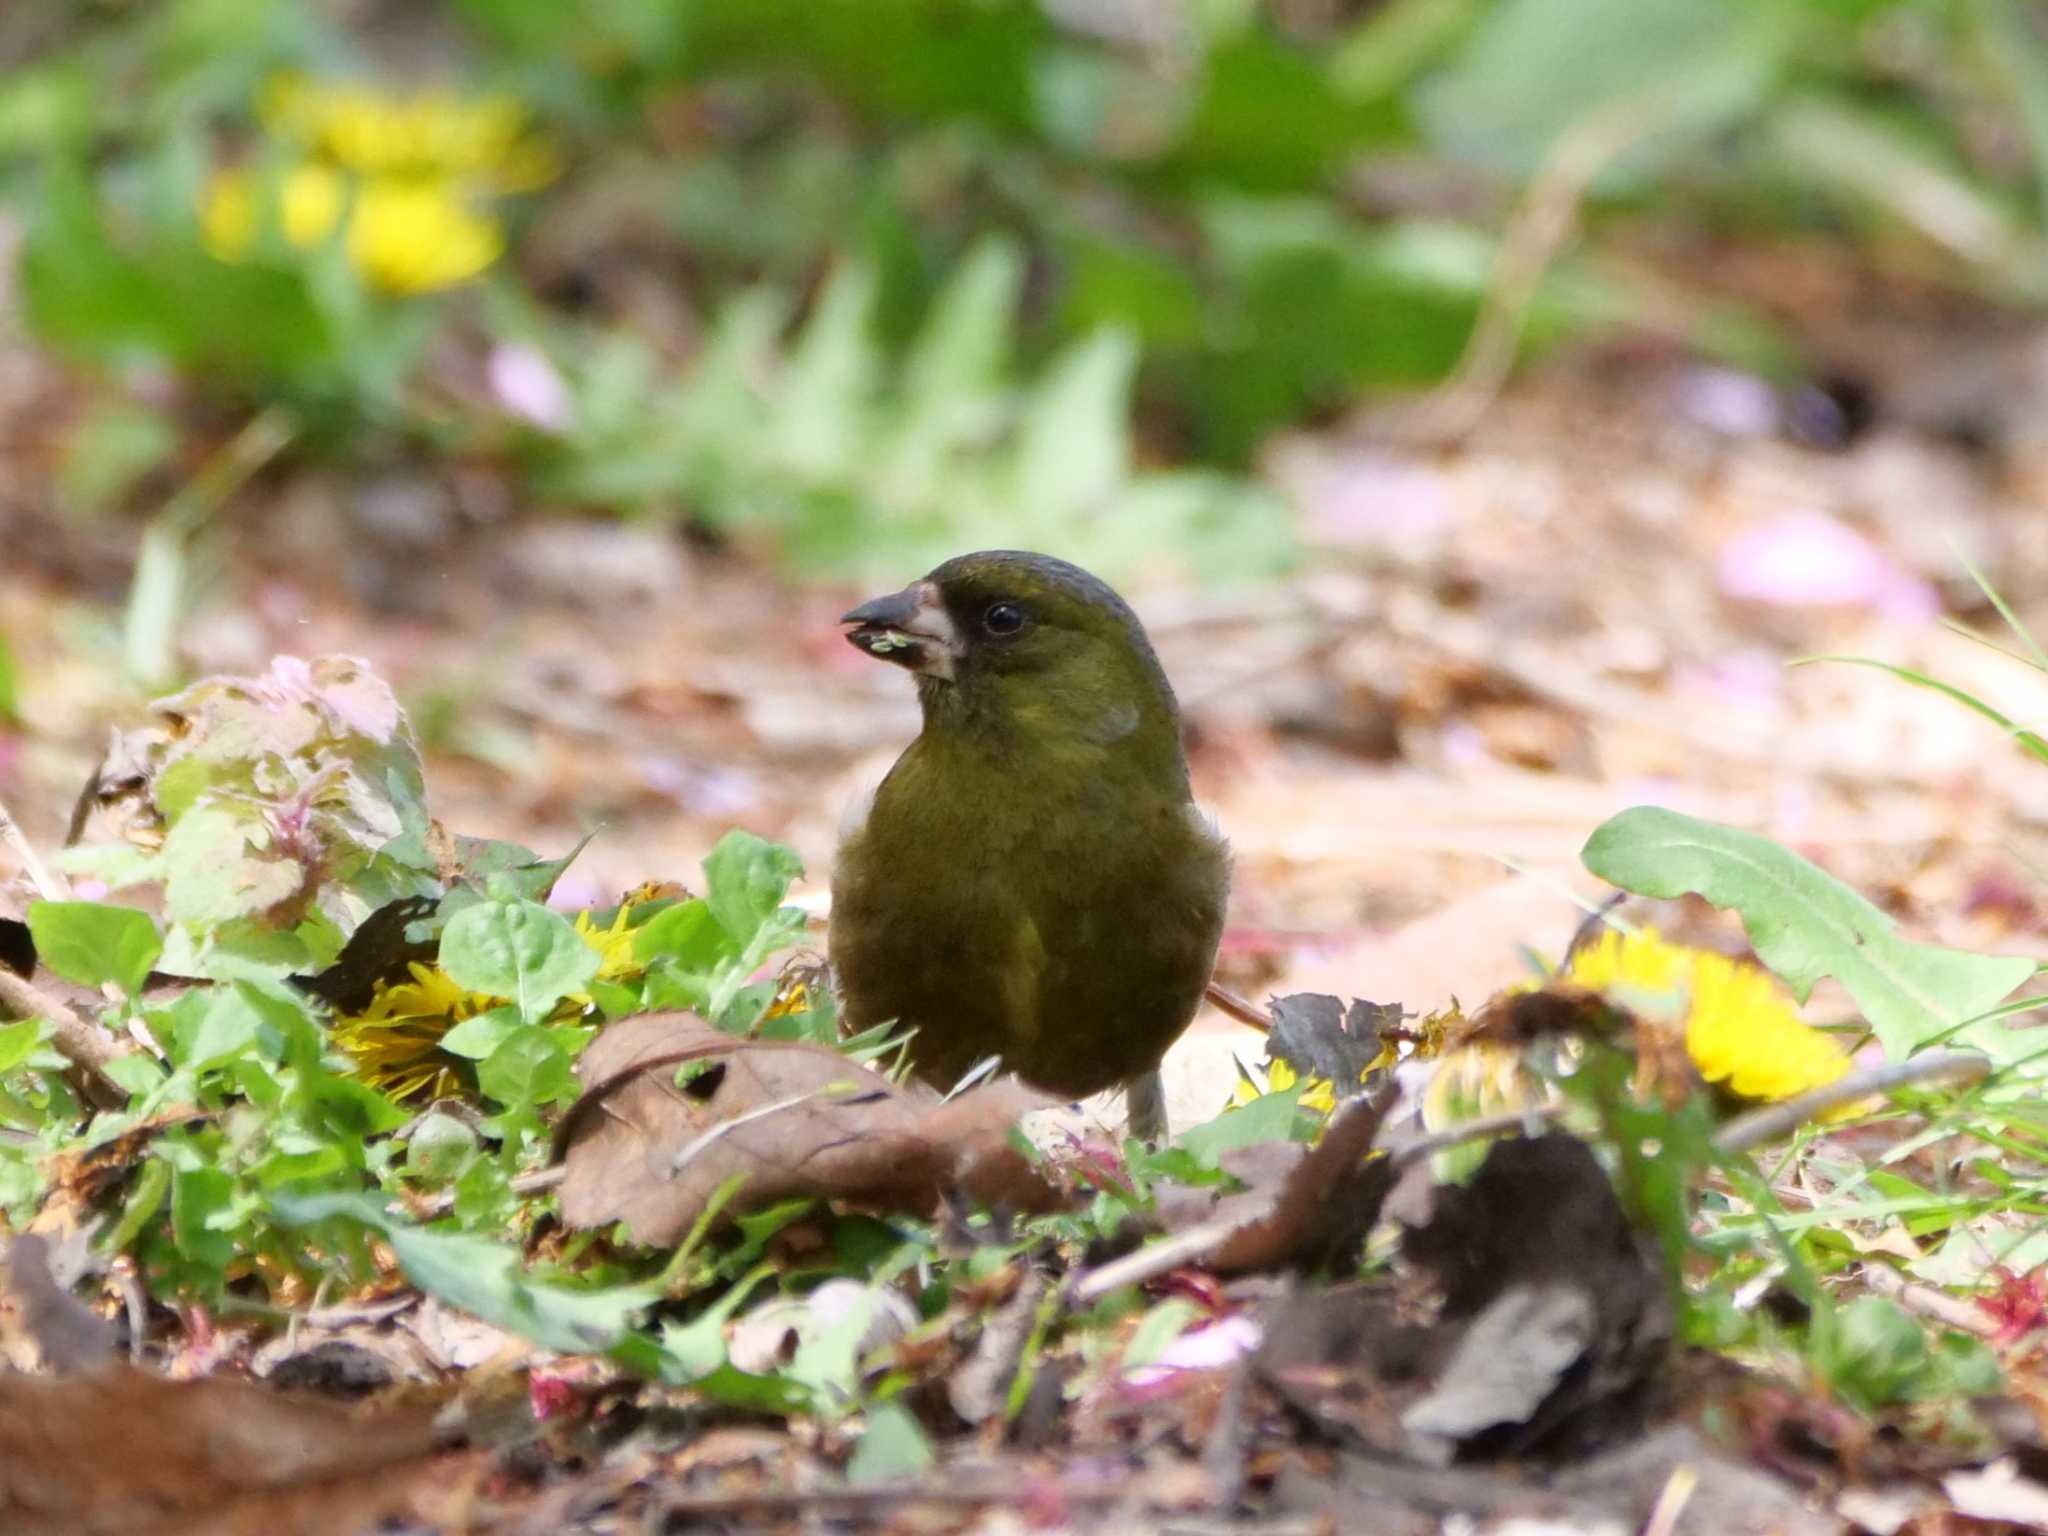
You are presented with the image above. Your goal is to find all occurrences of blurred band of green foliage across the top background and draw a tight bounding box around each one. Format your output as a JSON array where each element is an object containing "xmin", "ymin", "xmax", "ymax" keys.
[{"xmin": 12, "ymin": 0, "xmax": 2048, "ymax": 567}]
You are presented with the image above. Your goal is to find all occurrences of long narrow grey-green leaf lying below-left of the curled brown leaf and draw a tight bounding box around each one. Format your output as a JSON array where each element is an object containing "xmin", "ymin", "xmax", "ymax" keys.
[{"xmin": 272, "ymin": 1192, "xmax": 662, "ymax": 1354}]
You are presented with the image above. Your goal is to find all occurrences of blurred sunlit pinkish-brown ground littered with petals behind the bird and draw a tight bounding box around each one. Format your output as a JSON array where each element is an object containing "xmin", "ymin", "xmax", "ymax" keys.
[{"xmin": 0, "ymin": 340, "xmax": 2048, "ymax": 1112}]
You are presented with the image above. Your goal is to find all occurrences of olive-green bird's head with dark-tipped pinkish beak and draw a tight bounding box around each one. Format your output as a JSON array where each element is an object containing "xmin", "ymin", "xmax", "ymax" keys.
[{"xmin": 842, "ymin": 549, "xmax": 1180, "ymax": 762}]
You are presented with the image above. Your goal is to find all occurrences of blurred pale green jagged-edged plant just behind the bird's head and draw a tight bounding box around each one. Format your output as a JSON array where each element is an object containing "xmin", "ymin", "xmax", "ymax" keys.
[{"xmin": 535, "ymin": 240, "xmax": 1292, "ymax": 580}]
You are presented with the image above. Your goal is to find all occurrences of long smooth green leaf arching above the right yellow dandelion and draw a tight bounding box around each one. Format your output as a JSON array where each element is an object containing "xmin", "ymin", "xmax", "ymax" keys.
[{"xmin": 1583, "ymin": 805, "xmax": 2036, "ymax": 1061}]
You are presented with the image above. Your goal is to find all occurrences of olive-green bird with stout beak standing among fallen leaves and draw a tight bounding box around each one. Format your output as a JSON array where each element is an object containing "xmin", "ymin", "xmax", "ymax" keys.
[{"xmin": 829, "ymin": 551, "xmax": 1231, "ymax": 1139}]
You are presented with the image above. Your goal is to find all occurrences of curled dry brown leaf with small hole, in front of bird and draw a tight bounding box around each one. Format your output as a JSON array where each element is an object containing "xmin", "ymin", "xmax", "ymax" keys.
[{"xmin": 557, "ymin": 1014, "xmax": 1067, "ymax": 1247}]
